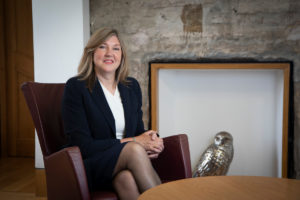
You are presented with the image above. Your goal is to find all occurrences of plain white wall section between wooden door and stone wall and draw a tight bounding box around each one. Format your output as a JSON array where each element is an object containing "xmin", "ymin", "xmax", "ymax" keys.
[{"xmin": 32, "ymin": 0, "xmax": 90, "ymax": 168}]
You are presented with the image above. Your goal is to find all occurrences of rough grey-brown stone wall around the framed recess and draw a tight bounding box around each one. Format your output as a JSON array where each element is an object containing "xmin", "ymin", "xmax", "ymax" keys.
[{"xmin": 90, "ymin": 0, "xmax": 300, "ymax": 179}]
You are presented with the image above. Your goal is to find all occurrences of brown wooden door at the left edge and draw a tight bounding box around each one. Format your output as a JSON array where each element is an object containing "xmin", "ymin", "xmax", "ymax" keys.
[{"xmin": 1, "ymin": 0, "xmax": 34, "ymax": 157}]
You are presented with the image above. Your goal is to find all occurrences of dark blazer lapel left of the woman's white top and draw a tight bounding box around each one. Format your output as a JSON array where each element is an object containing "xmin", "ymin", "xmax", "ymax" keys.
[{"xmin": 92, "ymin": 80, "xmax": 116, "ymax": 134}]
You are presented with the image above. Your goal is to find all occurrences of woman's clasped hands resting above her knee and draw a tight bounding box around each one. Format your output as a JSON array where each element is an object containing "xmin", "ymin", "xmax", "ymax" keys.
[{"xmin": 135, "ymin": 130, "xmax": 164, "ymax": 159}]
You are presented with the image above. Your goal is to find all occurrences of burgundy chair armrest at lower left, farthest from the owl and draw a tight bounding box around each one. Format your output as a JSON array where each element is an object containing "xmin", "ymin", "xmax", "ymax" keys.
[{"xmin": 44, "ymin": 147, "xmax": 90, "ymax": 200}]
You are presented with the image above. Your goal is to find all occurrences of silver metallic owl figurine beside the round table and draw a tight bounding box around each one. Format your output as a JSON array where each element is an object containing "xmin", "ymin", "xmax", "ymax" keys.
[{"xmin": 193, "ymin": 131, "xmax": 233, "ymax": 177}]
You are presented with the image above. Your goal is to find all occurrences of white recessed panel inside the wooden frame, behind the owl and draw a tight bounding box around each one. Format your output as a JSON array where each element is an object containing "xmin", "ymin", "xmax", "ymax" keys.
[{"xmin": 158, "ymin": 69, "xmax": 283, "ymax": 177}]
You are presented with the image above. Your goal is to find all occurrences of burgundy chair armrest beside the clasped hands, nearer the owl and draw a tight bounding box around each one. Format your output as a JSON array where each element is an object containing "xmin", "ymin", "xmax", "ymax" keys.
[{"xmin": 152, "ymin": 134, "xmax": 192, "ymax": 182}]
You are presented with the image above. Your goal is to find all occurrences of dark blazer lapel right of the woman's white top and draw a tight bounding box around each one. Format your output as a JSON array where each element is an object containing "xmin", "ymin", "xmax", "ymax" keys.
[{"xmin": 118, "ymin": 83, "xmax": 131, "ymax": 136}]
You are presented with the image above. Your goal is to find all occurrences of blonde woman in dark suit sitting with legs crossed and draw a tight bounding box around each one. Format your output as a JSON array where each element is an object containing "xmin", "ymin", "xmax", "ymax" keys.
[{"xmin": 62, "ymin": 28, "xmax": 164, "ymax": 199}]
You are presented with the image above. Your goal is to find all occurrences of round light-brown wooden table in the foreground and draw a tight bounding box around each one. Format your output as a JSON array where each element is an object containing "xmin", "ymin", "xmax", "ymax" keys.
[{"xmin": 138, "ymin": 176, "xmax": 300, "ymax": 200}]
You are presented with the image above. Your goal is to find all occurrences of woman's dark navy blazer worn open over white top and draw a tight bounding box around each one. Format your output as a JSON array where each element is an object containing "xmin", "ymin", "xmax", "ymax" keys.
[{"xmin": 62, "ymin": 77, "xmax": 145, "ymax": 159}]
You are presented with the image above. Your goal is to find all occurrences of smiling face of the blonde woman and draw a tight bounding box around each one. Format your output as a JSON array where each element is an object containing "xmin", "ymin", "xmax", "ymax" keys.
[{"xmin": 93, "ymin": 35, "xmax": 122, "ymax": 77}]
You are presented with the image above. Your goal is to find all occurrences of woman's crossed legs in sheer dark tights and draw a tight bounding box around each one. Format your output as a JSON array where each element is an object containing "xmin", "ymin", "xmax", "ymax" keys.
[{"xmin": 113, "ymin": 142, "xmax": 161, "ymax": 200}]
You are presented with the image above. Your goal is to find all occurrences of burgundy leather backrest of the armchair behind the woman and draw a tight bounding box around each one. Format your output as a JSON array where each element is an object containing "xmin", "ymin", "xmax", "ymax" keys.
[{"xmin": 21, "ymin": 82, "xmax": 66, "ymax": 156}]
